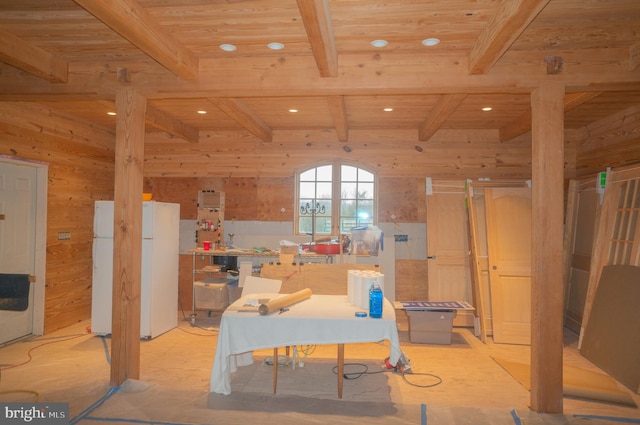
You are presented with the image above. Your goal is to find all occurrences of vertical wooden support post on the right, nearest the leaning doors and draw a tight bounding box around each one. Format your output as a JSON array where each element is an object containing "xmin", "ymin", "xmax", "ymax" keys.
[{"xmin": 531, "ymin": 81, "xmax": 564, "ymax": 413}]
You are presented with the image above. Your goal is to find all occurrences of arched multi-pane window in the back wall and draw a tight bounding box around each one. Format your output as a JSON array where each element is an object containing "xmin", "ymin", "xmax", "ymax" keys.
[{"xmin": 296, "ymin": 162, "xmax": 377, "ymax": 235}]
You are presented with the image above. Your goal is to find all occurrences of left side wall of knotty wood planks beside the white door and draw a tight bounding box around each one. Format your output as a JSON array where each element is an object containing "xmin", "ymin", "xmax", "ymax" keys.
[{"xmin": 0, "ymin": 102, "xmax": 115, "ymax": 333}]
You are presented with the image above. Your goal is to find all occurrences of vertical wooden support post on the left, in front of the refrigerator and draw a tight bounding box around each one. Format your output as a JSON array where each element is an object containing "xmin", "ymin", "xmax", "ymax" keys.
[{"xmin": 111, "ymin": 89, "xmax": 146, "ymax": 385}]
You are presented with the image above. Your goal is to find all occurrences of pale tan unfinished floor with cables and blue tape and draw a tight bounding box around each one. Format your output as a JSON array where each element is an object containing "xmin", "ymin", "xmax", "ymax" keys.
[{"xmin": 0, "ymin": 313, "xmax": 640, "ymax": 425}]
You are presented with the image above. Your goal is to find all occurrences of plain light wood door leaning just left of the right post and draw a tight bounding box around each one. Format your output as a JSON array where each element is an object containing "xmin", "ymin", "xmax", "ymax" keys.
[{"xmin": 485, "ymin": 187, "xmax": 531, "ymax": 344}]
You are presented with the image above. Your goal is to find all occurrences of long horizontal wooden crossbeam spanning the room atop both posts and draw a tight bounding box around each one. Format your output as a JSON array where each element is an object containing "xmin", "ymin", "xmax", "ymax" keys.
[{"xmin": 0, "ymin": 47, "xmax": 640, "ymax": 101}]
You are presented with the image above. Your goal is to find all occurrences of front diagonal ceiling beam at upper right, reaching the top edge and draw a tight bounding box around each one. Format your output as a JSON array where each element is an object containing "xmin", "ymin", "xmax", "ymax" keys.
[{"xmin": 469, "ymin": 0, "xmax": 550, "ymax": 75}]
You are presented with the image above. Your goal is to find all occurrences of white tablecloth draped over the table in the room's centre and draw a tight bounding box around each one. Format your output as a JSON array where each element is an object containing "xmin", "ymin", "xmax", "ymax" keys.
[{"xmin": 209, "ymin": 295, "xmax": 401, "ymax": 395}]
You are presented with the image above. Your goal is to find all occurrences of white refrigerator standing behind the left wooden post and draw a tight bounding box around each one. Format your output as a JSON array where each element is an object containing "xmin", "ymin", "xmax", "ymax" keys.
[{"xmin": 91, "ymin": 201, "xmax": 180, "ymax": 339}]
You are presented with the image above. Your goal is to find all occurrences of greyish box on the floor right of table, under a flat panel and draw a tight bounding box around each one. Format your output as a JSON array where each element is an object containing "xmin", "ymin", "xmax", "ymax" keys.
[{"xmin": 407, "ymin": 310, "xmax": 457, "ymax": 344}]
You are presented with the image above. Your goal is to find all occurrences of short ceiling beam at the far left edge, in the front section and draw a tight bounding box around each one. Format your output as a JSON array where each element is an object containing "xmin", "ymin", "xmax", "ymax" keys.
[{"xmin": 0, "ymin": 30, "xmax": 69, "ymax": 83}]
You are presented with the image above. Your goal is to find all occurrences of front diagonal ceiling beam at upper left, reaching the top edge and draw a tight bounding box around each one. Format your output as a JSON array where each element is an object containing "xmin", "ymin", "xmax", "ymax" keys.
[{"xmin": 74, "ymin": 0, "xmax": 199, "ymax": 80}]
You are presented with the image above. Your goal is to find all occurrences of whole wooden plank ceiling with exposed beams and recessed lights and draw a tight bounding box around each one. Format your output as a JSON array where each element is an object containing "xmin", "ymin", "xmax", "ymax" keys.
[{"xmin": 0, "ymin": 0, "xmax": 640, "ymax": 152}]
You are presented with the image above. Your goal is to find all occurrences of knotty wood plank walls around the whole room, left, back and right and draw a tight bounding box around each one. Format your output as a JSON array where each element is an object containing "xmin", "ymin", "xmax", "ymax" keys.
[{"xmin": 0, "ymin": 102, "xmax": 640, "ymax": 332}]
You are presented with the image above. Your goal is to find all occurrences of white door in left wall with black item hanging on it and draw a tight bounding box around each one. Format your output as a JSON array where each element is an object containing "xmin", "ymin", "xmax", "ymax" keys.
[{"xmin": 0, "ymin": 162, "xmax": 37, "ymax": 343}]
